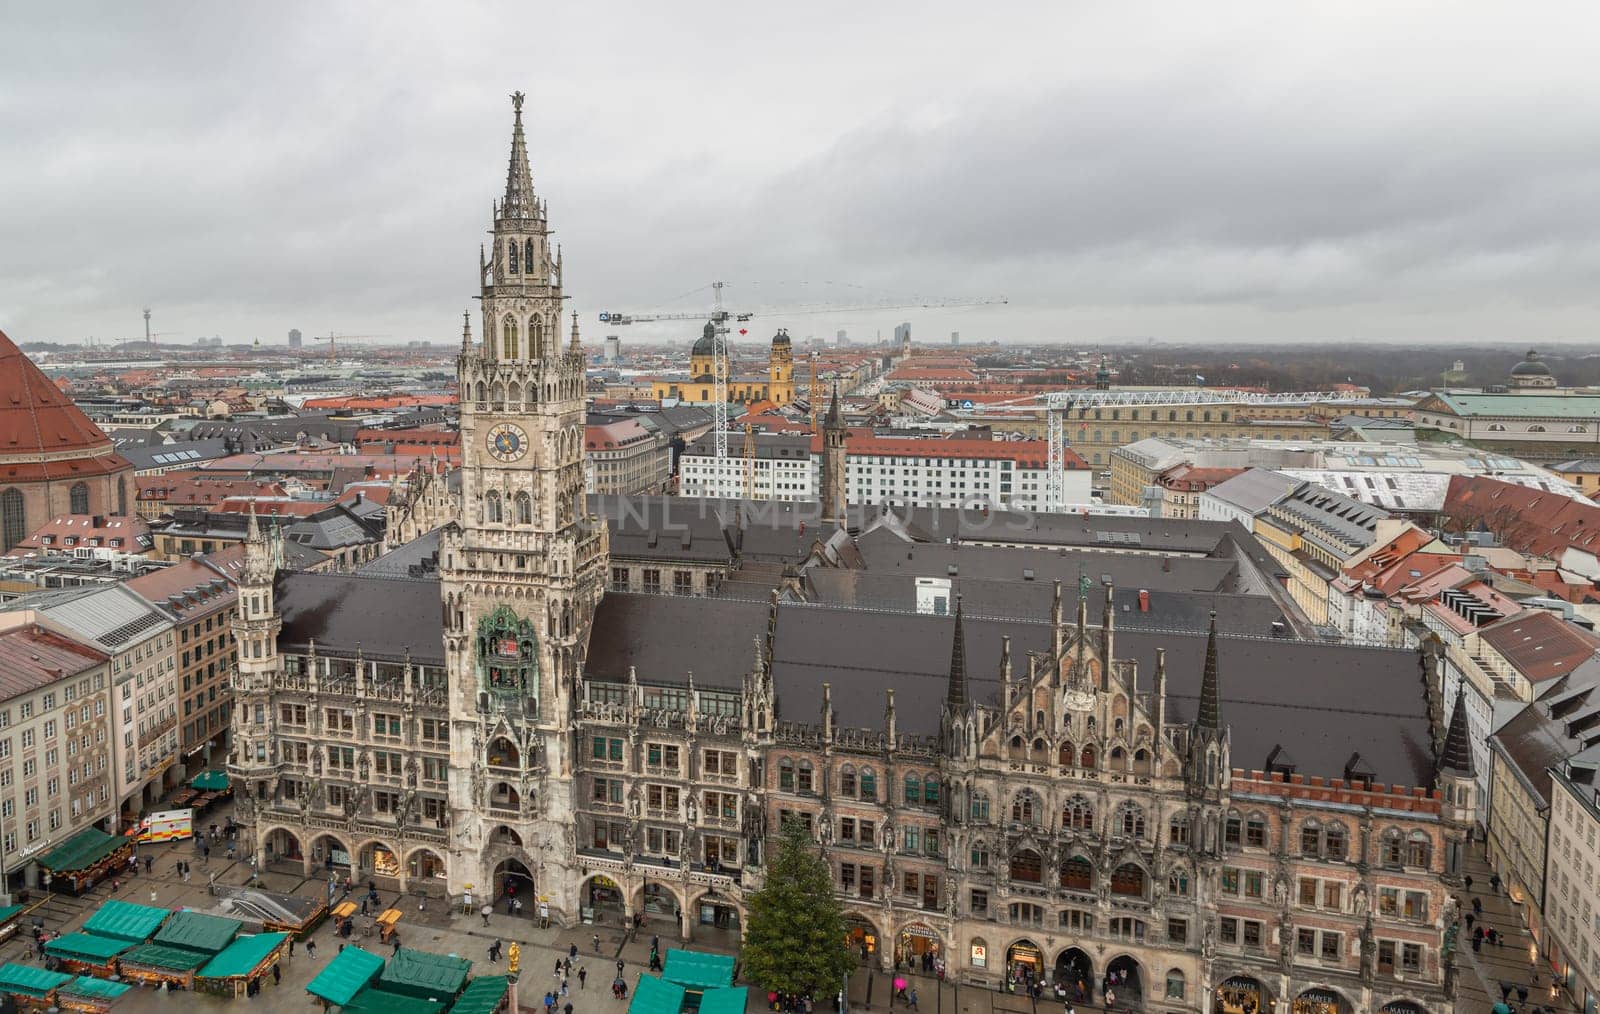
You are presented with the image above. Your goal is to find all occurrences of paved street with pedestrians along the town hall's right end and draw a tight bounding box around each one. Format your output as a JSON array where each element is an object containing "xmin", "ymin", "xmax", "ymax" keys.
[{"xmin": 1456, "ymin": 843, "xmax": 1578, "ymax": 1014}]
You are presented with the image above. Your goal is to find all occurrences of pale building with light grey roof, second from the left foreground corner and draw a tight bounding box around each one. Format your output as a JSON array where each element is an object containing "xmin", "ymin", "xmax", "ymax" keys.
[{"xmin": 0, "ymin": 584, "xmax": 179, "ymax": 830}]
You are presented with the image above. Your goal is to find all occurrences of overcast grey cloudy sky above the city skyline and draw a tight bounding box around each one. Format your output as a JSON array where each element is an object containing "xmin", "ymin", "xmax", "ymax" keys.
[{"xmin": 0, "ymin": 0, "xmax": 1600, "ymax": 342}]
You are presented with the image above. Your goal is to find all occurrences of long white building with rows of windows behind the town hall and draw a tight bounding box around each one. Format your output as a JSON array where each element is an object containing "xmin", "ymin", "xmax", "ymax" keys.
[{"xmin": 678, "ymin": 432, "xmax": 1093, "ymax": 510}]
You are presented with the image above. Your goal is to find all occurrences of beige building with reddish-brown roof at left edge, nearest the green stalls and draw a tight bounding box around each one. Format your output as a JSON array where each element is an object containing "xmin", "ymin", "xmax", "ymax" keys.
[{"xmin": 0, "ymin": 625, "xmax": 112, "ymax": 894}]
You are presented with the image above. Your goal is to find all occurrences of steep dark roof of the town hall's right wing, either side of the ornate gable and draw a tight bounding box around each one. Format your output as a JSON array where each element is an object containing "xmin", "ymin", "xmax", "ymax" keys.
[{"xmin": 773, "ymin": 597, "xmax": 1434, "ymax": 785}]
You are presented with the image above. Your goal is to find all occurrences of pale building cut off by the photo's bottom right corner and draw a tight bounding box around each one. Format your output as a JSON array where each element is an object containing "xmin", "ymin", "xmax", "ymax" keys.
[{"xmin": 1544, "ymin": 758, "xmax": 1600, "ymax": 1011}]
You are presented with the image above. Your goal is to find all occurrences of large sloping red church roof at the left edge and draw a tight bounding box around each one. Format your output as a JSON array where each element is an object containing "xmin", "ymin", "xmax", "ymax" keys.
[{"xmin": 0, "ymin": 331, "xmax": 133, "ymax": 467}]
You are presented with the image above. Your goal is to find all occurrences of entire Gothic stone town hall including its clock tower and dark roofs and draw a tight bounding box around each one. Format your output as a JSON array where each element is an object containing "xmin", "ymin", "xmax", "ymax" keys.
[{"xmin": 230, "ymin": 96, "xmax": 1475, "ymax": 1014}]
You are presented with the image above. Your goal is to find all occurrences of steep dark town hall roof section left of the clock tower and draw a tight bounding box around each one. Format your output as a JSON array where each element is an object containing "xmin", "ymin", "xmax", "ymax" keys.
[{"xmin": 275, "ymin": 573, "xmax": 445, "ymax": 665}]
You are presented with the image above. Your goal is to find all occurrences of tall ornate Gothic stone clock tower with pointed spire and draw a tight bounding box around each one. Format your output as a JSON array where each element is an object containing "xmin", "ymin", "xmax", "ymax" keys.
[{"xmin": 440, "ymin": 93, "xmax": 606, "ymax": 918}]
